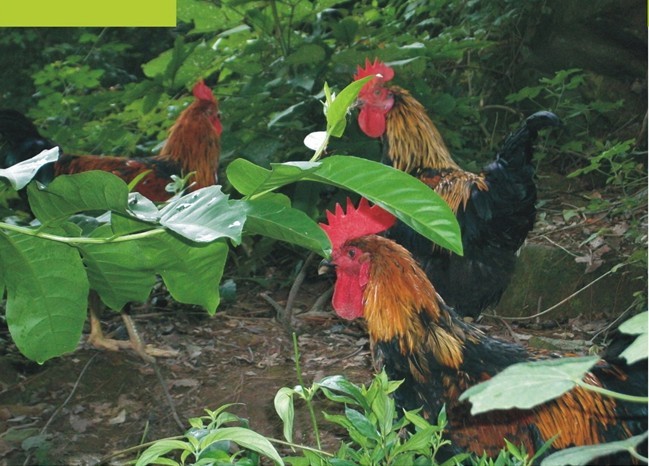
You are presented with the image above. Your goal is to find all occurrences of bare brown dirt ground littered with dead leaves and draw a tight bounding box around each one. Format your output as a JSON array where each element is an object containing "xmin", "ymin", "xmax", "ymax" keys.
[{"xmin": 0, "ymin": 173, "xmax": 646, "ymax": 466}]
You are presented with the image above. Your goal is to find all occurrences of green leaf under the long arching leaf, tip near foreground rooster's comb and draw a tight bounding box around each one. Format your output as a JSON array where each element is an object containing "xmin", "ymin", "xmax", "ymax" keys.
[{"xmin": 240, "ymin": 195, "xmax": 331, "ymax": 256}]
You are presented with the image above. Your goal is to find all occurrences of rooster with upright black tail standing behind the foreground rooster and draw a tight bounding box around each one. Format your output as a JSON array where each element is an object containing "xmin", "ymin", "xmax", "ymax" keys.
[{"xmin": 354, "ymin": 60, "xmax": 560, "ymax": 318}]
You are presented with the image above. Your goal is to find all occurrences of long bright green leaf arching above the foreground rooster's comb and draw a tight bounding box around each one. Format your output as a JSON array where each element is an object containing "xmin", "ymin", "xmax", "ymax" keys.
[{"xmin": 228, "ymin": 156, "xmax": 462, "ymax": 254}]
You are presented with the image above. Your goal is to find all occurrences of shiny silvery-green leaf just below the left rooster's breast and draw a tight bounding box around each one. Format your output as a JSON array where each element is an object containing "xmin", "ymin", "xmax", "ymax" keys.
[{"xmin": 160, "ymin": 186, "xmax": 246, "ymax": 244}]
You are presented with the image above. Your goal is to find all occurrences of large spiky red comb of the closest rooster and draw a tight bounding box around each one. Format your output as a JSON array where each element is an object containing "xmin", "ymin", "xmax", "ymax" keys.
[{"xmin": 320, "ymin": 198, "xmax": 397, "ymax": 249}]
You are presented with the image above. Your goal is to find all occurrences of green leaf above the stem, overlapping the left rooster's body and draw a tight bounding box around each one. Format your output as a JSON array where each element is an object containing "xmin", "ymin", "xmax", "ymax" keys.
[{"xmin": 27, "ymin": 171, "xmax": 128, "ymax": 224}]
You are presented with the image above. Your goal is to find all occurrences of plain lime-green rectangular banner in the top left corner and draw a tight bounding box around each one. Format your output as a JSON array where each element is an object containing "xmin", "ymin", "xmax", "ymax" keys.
[{"xmin": 0, "ymin": 0, "xmax": 176, "ymax": 27}]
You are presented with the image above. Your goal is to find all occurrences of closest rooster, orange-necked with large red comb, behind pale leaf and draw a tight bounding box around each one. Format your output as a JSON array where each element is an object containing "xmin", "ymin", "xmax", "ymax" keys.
[{"xmin": 320, "ymin": 200, "xmax": 647, "ymax": 464}]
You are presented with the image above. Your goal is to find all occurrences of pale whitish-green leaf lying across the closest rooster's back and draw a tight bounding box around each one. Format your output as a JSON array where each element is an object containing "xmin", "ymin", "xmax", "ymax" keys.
[{"xmin": 460, "ymin": 356, "xmax": 598, "ymax": 415}]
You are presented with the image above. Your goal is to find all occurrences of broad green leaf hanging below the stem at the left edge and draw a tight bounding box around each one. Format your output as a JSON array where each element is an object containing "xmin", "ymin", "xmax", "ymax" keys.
[{"xmin": 0, "ymin": 231, "xmax": 88, "ymax": 363}]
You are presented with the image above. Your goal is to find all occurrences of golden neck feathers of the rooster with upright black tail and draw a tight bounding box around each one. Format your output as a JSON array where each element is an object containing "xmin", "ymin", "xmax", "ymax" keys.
[{"xmin": 386, "ymin": 86, "xmax": 460, "ymax": 173}]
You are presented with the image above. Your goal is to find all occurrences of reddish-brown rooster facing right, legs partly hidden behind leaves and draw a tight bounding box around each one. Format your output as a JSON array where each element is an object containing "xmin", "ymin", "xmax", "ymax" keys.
[{"xmin": 0, "ymin": 80, "xmax": 223, "ymax": 360}]
